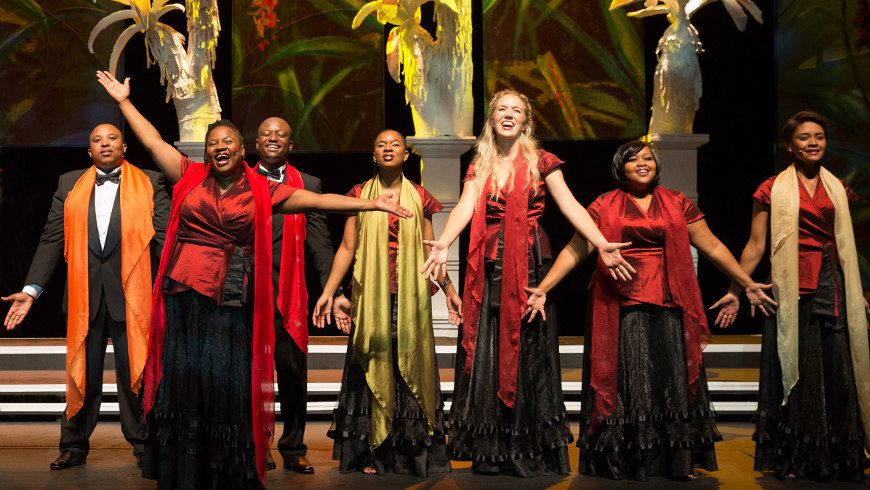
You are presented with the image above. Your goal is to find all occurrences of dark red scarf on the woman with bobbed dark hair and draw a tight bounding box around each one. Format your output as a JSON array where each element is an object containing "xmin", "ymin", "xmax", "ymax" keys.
[{"xmin": 589, "ymin": 186, "xmax": 710, "ymax": 432}]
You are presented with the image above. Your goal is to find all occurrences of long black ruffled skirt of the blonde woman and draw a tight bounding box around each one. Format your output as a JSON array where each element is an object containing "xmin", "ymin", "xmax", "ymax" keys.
[{"xmin": 448, "ymin": 260, "xmax": 574, "ymax": 477}]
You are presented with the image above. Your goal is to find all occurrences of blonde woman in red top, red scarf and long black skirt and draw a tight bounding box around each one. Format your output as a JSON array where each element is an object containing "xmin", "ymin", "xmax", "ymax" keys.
[{"xmin": 422, "ymin": 90, "xmax": 633, "ymax": 477}]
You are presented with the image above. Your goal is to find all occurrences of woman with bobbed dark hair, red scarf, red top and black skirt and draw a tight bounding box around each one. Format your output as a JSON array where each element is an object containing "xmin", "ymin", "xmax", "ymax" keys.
[{"xmin": 529, "ymin": 141, "xmax": 770, "ymax": 481}]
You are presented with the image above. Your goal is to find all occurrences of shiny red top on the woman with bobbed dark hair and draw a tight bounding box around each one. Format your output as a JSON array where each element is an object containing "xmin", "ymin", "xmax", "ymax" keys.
[{"xmin": 586, "ymin": 193, "xmax": 704, "ymax": 307}]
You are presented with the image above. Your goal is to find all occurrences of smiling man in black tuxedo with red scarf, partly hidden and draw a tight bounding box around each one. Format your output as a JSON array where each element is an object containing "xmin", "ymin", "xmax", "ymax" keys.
[{"xmin": 256, "ymin": 117, "xmax": 334, "ymax": 474}]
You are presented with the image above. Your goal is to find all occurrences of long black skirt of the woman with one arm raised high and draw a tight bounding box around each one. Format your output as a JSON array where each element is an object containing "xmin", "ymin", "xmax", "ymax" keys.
[{"xmin": 142, "ymin": 291, "xmax": 261, "ymax": 488}]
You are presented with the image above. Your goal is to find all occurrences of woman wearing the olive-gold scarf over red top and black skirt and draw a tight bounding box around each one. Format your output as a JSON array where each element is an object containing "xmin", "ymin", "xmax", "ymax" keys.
[{"xmin": 314, "ymin": 130, "xmax": 462, "ymax": 477}]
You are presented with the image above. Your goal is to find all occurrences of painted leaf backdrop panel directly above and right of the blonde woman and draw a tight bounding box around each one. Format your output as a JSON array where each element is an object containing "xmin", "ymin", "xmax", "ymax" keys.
[{"xmin": 483, "ymin": 0, "xmax": 648, "ymax": 139}]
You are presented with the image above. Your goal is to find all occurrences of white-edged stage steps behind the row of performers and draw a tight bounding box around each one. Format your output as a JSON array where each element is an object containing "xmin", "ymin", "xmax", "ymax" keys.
[{"xmin": 0, "ymin": 336, "xmax": 761, "ymax": 419}]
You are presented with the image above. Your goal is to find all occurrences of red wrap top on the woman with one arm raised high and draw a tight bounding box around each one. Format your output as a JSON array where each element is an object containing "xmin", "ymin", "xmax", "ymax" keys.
[{"xmin": 164, "ymin": 158, "xmax": 296, "ymax": 303}]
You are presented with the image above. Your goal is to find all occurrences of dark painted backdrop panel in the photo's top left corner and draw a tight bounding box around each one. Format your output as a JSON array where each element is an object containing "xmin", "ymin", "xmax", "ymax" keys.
[{"xmin": 0, "ymin": 0, "xmax": 120, "ymax": 146}]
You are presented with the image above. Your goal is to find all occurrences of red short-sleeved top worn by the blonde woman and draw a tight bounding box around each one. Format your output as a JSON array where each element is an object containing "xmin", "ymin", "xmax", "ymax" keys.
[{"xmin": 462, "ymin": 150, "xmax": 565, "ymax": 260}]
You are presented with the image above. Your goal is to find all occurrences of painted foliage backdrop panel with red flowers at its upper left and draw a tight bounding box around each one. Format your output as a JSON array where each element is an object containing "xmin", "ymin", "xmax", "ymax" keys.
[{"xmin": 232, "ymin": 0, "xmax": 384, "ymax": 151}]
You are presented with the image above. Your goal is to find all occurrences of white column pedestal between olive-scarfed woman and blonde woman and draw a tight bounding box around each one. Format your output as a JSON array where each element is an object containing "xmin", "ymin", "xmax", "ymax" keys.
[{"xmin": 408, "ymin": 136, "xmax": 477, "ymax": 338}]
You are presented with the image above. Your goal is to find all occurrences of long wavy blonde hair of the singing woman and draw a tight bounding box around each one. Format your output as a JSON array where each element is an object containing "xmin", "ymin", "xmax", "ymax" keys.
[{"xmin": 472, "ymin": 90, "xmax": 541, "ymax": 200}]
